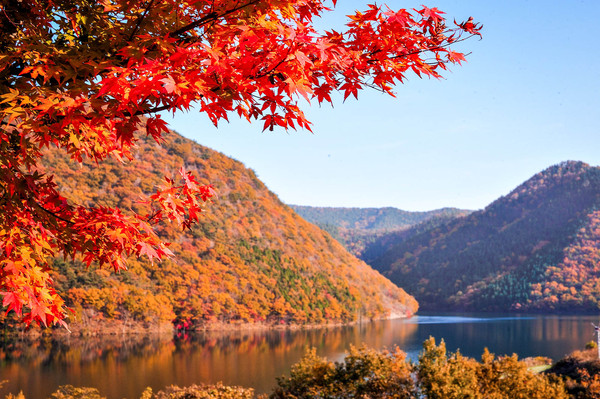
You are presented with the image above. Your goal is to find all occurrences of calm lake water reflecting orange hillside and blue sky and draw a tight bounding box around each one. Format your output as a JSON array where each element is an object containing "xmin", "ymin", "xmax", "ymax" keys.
[{"xmin": 0, "ymin": 315, "xmax": 598, "ymax": 399}]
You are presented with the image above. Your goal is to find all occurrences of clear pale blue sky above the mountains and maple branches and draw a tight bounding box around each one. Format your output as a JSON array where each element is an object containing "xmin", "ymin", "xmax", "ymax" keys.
[{"xmin": 166, "ymin": 0, "xmax": 600, "ymax": 211}]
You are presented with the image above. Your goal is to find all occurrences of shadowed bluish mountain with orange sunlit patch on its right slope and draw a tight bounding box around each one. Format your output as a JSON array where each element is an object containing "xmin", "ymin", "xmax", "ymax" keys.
[{"xmin": 371, "ymin": 161, "xmax": 600, "ymax": 312}]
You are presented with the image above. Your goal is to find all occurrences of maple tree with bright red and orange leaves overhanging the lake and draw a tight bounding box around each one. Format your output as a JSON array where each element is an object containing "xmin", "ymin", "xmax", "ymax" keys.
[{"xmin": 0, "ymin": 0, "xmax": 480, "ymax": 325}]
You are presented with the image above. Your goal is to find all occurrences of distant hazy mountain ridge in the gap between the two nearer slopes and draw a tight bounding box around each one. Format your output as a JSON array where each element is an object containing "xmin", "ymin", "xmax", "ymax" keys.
[{"xmin": 290, "ymin": 205, "xmax": 471, "ymax": 263}]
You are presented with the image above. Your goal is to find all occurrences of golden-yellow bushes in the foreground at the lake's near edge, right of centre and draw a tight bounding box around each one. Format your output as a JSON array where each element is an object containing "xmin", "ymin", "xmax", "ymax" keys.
[{"xmin": 270, "ymin": 337, "xmax": 568, "ymax": 399}]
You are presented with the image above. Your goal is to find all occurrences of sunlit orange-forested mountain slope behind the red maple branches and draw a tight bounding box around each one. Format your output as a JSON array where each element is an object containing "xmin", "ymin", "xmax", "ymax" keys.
[{"xmin": 19, "ymin": 133, "xmax": 417, "ymax": 327}]
